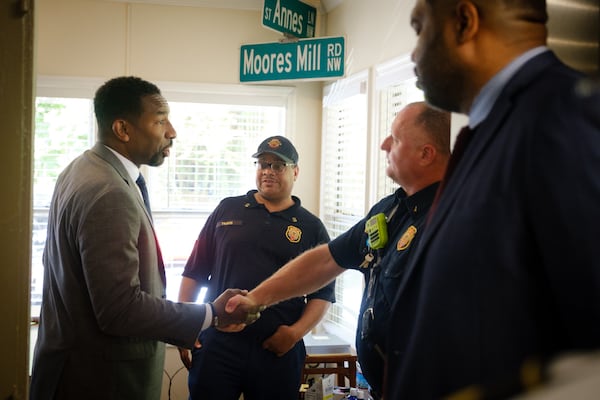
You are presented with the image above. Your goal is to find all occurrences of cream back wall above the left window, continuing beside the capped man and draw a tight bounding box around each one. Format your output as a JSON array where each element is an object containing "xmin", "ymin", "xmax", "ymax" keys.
[{"xmin": 36, "ymin": 0, "xmax": 321, "ymax": 213}]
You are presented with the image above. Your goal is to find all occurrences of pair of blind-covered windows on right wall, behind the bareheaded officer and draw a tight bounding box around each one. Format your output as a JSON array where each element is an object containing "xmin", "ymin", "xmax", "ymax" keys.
[{"xmin": 321, "ymin": 57, "xmax": 423, "ymax": 343}]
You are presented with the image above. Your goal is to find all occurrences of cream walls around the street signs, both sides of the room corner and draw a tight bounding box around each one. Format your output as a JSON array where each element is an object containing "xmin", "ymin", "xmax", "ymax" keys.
[{"xmin": 36, "ymin": 0, "xmax": 462, "ymax": 214}]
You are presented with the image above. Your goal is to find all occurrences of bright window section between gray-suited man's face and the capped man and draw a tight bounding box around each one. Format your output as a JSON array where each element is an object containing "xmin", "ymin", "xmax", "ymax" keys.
[{"xmin": 144, "ymin": 102, "xmax": 285, "ymax": 301}]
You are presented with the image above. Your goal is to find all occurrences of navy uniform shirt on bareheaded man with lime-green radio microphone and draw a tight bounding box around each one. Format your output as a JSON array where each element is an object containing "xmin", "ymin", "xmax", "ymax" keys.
[{"xmin": 329, "ymin": 183, "xmax": 438, "ymax": 393}]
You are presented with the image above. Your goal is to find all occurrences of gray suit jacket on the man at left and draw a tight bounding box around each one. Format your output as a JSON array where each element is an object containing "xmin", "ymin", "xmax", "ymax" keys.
[{"xmin": 30, "ymin": 144, "xmax": 205, "ymax": 400}]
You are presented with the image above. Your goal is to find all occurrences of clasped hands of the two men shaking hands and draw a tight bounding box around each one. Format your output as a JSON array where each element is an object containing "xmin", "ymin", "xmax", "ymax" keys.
[{"xmin": 210, "ymin": 289, "xmax": 266, "ymax": 332}]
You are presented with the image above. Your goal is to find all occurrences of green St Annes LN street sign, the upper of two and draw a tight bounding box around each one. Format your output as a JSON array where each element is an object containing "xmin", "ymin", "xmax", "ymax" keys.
[{"xmin": 262, "ymin": 0, "xmax": 317, "ymax": 38}]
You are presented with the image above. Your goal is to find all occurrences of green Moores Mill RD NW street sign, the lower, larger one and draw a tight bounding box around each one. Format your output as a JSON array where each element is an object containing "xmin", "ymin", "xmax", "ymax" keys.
[{"xmin": 240, "ymin": 36, "xmax": 344, "ymax": 82}]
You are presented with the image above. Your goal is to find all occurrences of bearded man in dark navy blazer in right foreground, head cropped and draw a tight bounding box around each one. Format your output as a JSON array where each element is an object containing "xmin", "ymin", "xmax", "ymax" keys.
[{"xmin": 384, "ymin": 0, "xmax": 600, "ymax": 400}]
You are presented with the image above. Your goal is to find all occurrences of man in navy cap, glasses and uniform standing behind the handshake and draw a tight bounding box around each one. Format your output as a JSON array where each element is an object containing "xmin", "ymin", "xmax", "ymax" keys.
[{"xmin": 179, "ymin": 136, "xmax": 335, "ymax": 400}]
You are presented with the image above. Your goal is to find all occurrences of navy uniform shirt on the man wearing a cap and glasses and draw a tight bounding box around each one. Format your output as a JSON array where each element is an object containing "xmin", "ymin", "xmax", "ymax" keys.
[{"xmin": 183, "ymin": 190, "xmax": 335, "ymax": 339}]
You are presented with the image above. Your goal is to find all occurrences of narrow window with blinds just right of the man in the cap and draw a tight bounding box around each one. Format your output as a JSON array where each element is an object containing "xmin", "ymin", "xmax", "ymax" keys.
[{"xmin": 321, "ymin": 72, "xmax": 368, "ymax": 343}]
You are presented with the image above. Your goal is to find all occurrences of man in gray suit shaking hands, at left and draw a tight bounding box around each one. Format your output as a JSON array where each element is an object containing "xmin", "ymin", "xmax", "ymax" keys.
[{"xmin": 30, "ymin": 77, "xmax": 258, "ymax": 400}]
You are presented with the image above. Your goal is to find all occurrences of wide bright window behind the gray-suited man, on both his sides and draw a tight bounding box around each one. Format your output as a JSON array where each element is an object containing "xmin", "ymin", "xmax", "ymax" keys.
[{"xmin": 31, "ymin": 77, "xmax": 293, "ymax": 316}]
